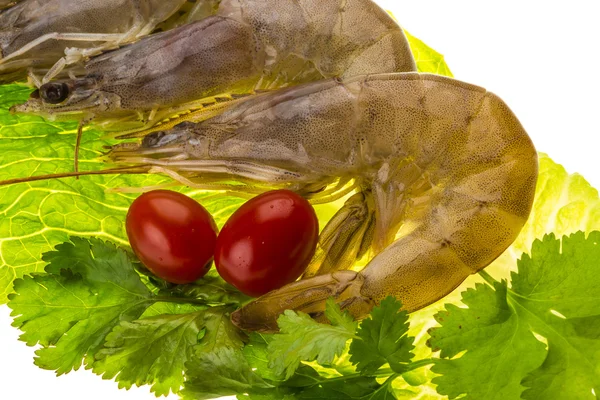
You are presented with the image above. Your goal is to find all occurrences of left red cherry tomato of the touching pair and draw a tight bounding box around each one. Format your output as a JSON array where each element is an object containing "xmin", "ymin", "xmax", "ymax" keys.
[{"xmin": 125, "ymin": 190, "xmax": 218, "ymax": 284}]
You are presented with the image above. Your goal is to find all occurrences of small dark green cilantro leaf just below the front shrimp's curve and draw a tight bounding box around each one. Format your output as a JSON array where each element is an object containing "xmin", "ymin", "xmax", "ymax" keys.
[{"xmin": 350, "ymin": 296, "xmax": 414, "ymax": 375}]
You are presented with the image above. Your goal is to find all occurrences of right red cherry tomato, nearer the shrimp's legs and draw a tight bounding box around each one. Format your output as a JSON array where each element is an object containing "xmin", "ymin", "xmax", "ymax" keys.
[{"xmin": 215, "ymin": 190, "xmax": 319, "ymax": 297}]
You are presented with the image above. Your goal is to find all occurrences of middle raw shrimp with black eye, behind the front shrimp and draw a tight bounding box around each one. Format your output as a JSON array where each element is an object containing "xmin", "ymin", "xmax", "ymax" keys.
[{"xmin": 15, "ymin": 0, "xmax": 416, "ymax": 129}]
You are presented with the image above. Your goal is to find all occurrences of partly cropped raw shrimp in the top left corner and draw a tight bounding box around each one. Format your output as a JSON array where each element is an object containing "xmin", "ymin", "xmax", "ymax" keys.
[{"xmin": 0, "ymin": 0, "xmax": 186, "ymax": 85}]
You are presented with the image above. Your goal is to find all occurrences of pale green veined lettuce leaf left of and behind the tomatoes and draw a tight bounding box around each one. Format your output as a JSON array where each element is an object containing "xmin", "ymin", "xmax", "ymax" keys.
[{"xmin": 0, "ymin": 85, "xmax": 339, "ymax": 304}]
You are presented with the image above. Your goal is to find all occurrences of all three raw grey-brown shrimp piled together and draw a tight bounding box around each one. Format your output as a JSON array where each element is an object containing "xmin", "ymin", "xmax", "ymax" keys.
[{"xmin": 0, "ymin": 0, "xmax": 537, "ymax": 332}]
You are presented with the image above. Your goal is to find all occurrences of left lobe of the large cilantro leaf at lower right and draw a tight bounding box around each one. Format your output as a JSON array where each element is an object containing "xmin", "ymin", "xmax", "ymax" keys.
[{"xmin": 430, "ymin": 282, "xmax": 545, "ymax": 400}]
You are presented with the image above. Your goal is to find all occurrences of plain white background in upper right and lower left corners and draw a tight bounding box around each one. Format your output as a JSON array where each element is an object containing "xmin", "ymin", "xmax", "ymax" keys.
[{"xmin": 0, "ymin": 0, "xmax": 600, "ymax": 400}]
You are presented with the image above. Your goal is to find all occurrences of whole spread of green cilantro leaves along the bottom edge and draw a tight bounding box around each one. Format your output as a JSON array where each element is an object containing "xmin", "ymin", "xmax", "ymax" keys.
[{"xmin": 9, "ymin": 228, "xmax": 600, "ymax": 400}]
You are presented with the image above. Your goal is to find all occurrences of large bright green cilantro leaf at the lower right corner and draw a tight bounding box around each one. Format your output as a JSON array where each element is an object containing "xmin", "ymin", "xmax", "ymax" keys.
[{"xmin": 430, "ymin": 232, "xmax": 600, "ymax": 400}]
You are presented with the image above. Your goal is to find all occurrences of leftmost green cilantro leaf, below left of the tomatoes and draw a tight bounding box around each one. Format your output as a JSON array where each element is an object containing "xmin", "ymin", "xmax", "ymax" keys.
[{"xmin": 9, "ymin": 238, "xmax": 154, "ymax": 375}]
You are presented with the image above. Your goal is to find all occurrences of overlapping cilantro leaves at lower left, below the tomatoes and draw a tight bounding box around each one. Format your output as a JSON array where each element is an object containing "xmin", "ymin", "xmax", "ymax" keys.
[{"xmin": 9, "ymin": 238, "xmax": 243, "ymax": 395}]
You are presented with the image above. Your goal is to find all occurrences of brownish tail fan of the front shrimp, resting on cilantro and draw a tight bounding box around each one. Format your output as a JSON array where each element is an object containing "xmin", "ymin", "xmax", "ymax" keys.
[{"xmin": 231, "ymin": 271, "xmax": 375, "ymax": 332}]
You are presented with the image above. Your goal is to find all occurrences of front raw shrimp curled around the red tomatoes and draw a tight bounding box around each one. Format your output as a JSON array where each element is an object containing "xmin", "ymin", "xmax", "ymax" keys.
[{"xmin": 110, "ymin": 73, "xmax": 538, "ymax": 331}]
